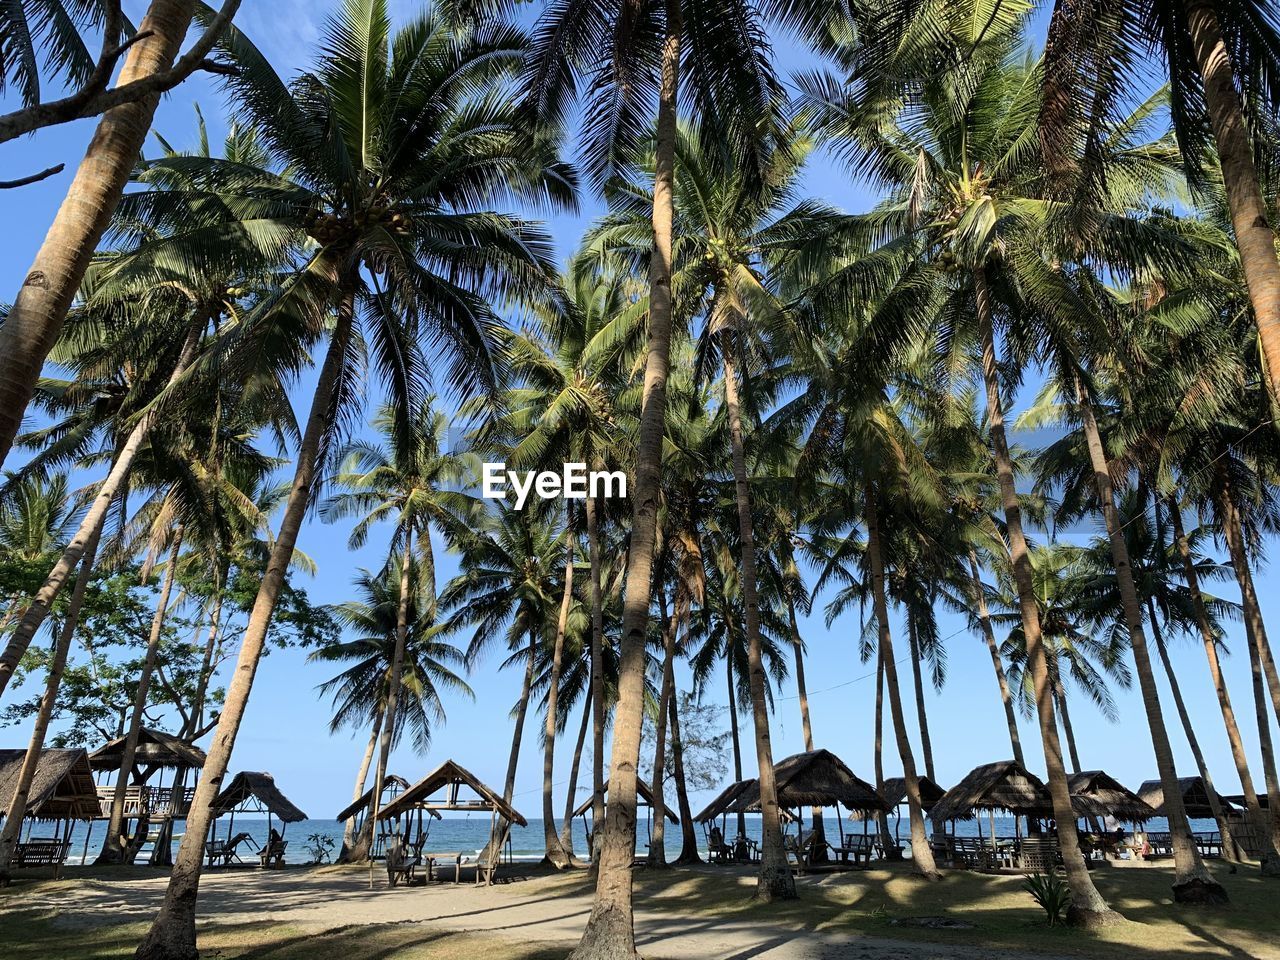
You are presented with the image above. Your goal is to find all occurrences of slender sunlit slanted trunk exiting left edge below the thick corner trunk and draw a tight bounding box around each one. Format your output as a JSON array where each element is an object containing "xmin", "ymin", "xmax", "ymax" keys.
[{"xmin": 0, "ymin": 323, "xmax": 205, "ymax": 696}]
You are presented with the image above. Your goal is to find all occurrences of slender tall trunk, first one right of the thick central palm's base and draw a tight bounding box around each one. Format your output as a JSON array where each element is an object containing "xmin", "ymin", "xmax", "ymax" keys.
[{"xmin": 722, "ymin": 350, "xmax": 796, "ymax": 902}]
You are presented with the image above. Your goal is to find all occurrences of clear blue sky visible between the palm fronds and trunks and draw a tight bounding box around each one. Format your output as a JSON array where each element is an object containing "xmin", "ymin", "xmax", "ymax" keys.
[{"xmin": 0, "ymin": 0, "xmax": 1280, "ymax": 818}]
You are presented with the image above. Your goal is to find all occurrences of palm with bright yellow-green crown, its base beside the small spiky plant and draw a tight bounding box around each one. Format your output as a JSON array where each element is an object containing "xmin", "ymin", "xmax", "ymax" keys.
[{"xmin": 803, "ymin": 32, "xmax": 1131, "ymax": 924}]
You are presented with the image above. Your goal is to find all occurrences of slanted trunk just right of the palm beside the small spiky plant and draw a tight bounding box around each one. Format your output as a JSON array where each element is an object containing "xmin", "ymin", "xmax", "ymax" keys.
[{"xmin": 973, "ymin": 266, "xmax": 1120, "ymax": 927}]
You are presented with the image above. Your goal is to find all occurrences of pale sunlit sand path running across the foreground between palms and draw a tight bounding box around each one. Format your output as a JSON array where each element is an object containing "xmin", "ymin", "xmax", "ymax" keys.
[{"xmin": 0, "ymin": 869, "xmax": 1070, "ymax": 960}]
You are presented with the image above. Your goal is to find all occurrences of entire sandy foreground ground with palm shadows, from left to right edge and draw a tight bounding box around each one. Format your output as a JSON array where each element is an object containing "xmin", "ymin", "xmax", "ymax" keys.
[{"xmin": 0, "ymin": 867, "xmax": 1280, "ymax": 960}]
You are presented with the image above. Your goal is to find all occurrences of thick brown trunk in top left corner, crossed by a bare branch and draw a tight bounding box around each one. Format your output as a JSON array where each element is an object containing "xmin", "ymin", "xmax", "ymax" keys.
[{"xmin": 0, "ymin": 0, "xmax": 196, "ymax": 471}]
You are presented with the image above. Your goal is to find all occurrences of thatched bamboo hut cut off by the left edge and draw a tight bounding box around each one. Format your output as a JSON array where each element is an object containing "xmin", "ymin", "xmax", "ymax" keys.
[{"xmin": 0, "ymin": 749, "xmax": 99, "ymax": 877}]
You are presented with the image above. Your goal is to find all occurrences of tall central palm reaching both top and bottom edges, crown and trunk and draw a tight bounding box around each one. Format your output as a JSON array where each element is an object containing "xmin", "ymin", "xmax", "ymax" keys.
[{"xmin": 529, "ymin": 0, "xmax": 798, "ymax": 942}]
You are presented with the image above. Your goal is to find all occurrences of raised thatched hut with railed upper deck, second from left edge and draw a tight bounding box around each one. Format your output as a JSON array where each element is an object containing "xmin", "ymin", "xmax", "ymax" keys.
[{"xmin": 84, "ymin": 727, "xmax": 205, "ymax": 867}]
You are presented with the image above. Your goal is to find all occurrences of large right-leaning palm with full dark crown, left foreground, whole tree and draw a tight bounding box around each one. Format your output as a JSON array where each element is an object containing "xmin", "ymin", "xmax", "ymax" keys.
[{"xmin": 137, "ymin": 0, "xmax": 571, "ymax": 960}]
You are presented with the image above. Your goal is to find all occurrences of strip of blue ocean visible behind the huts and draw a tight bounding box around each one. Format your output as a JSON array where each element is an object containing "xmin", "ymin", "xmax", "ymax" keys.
[{"xmin": 45, "ymin": 813, "xmax": 1198, "ymax": 864}]
